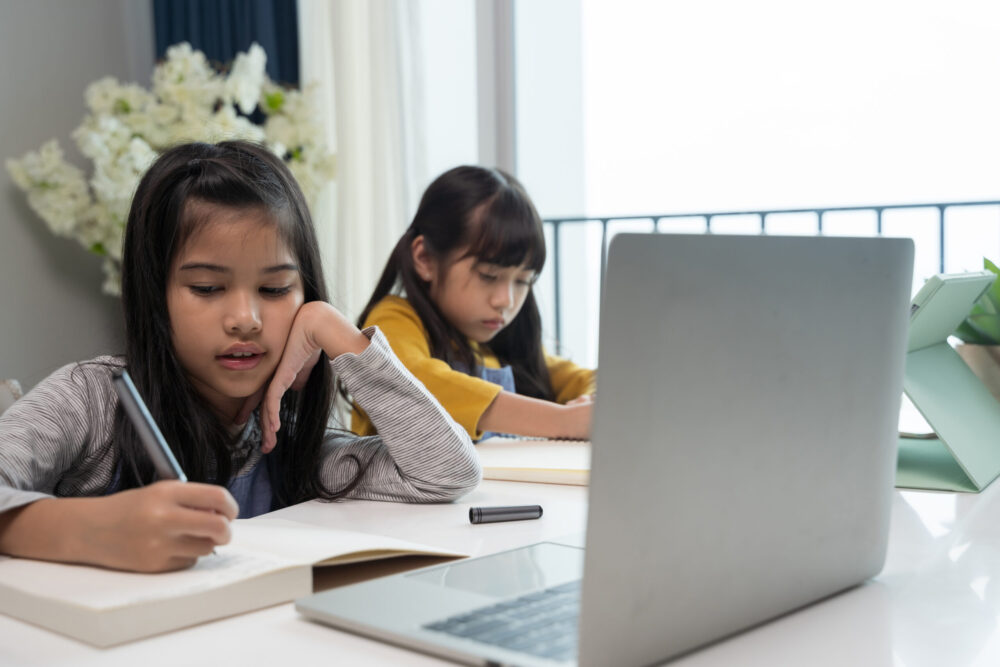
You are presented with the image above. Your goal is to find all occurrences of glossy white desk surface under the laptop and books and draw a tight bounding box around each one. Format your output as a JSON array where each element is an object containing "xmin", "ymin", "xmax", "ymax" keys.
[{"xmin": 0, "ymin": 482, "xmax": 1000, "ymax": 667}]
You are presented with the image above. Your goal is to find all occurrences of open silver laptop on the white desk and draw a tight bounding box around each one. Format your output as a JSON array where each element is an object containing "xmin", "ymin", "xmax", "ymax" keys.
[{"xmin": 296, "ymin": 234, "xmax": 913, "ymax": 666}]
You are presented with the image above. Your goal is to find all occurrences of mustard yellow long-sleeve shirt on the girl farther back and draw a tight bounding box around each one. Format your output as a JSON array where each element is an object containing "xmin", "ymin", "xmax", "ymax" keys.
[{"xmin": 351, "ymin": 296, "xmax": 597, "ymax": 439}]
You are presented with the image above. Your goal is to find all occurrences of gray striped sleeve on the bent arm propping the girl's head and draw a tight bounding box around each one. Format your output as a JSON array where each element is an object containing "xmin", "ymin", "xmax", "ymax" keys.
[{"xmin": 322, "ymin": 327, "xmax": 482, "ymax": 502}]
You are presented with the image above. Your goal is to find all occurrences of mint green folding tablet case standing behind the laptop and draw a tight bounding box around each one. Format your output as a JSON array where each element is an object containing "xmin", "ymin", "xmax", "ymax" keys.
[{"xmin": 896, "ymin": 271, "xmax": 1000, "ymax": 493}]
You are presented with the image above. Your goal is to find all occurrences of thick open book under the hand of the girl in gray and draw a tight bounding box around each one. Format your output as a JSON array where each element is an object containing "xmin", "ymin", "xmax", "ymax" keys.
[{"xmin": 0, "ymin": 518, "xmax": 467, "ymax": 646}]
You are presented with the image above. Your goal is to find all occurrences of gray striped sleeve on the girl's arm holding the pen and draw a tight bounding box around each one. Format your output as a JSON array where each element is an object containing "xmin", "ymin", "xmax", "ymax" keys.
[{"xmin": 0, "ymin": 357, "xmax": 120, "ymax": 512}]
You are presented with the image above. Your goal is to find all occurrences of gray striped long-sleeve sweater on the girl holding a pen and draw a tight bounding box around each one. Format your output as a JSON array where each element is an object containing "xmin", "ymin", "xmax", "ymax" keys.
[{"xmin": 0, "ymin": 327, "xmax": 482, "ymax": 512}]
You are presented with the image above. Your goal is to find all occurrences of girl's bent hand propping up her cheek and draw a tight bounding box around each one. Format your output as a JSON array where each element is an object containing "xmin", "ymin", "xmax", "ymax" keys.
[{"xmin": 260, "ymin": 301, "xmax": 369, "ymax": 454}]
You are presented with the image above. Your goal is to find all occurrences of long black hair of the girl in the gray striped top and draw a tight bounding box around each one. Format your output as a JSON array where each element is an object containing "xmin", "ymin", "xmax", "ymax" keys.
[{"xmin": 113, "ymin": 141, "xmax": 362, "ymax": 507}]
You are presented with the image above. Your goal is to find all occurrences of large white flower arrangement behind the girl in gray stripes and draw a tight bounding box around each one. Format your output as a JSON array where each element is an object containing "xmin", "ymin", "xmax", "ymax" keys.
[{"xmin": 7, "ymin": 43, "xmax": 336, "ymax": 294}]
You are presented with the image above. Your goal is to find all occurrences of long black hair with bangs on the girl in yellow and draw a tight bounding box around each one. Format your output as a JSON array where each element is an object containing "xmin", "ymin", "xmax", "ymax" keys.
[{"xmin": 358, "ymin": 166, "xmax": 555, "ymax": 401}]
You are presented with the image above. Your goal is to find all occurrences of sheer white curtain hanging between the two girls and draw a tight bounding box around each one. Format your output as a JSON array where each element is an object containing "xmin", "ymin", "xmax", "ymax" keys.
[{"xmin": 299, "ymin": 0, "xmax": 428, "ymax": 320}]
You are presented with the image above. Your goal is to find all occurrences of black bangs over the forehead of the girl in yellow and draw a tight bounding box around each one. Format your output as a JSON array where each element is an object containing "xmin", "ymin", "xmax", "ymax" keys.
[{"xmin": 463, "ymin": 188, "xmax": 545, "ymax": 273}]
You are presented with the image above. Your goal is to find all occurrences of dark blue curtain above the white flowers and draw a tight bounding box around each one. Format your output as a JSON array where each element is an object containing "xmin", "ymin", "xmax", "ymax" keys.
[{"xmin": 153, "ymin": 0, "xmax": 299, "ymax": 86}]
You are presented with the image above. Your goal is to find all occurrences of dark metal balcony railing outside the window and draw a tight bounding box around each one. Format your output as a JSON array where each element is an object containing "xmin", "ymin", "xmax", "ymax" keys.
[{"xmin": 544, "ymin": 200, "xmax": 1000, "ymax": 354}]
